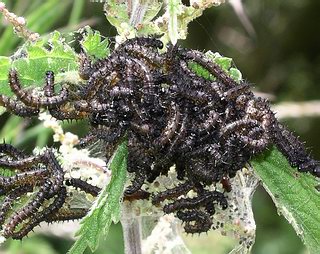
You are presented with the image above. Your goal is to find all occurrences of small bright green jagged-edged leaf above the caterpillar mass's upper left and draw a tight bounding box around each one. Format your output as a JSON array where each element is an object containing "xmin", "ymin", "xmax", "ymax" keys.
[{"xmin": 81, "ymin": 26, "xmax": 110, "ymax": 59}]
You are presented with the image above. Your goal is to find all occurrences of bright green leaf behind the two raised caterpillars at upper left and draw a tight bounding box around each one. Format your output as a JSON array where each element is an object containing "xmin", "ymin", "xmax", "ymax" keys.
[{"xmin": 0, "ymin": 32, "xmax": 78, "ymax": 96}]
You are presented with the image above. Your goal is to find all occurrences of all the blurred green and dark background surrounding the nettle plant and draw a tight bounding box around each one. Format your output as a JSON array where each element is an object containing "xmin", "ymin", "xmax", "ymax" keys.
[{"xmin": 0, "ymin": 0, "xmax": 320, "ymax": 254}]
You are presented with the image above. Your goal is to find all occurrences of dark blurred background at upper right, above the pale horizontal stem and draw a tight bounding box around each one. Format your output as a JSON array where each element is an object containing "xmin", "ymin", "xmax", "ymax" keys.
[{"xmin": 184, "ymin": 0, "xmax": 320, "ymax": 101}]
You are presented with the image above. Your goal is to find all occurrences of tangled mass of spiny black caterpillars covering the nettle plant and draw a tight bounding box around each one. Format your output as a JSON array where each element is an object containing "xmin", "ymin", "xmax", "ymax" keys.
[{"xmin": 0, "ymin": 38, "xmax": 320, "ymax": 238}]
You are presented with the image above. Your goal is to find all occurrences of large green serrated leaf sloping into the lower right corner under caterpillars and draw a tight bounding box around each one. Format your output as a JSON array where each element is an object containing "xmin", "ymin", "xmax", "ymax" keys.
[{"xmin": 251, "ymin": 149, "xmax": 320, "ymax": 253}]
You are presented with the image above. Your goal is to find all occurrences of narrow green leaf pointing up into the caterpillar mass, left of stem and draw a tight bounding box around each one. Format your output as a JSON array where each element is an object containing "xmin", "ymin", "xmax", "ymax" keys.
[{"xmin": 68, "ymin": 141, "xmax": 128, "ymax": 254}]
